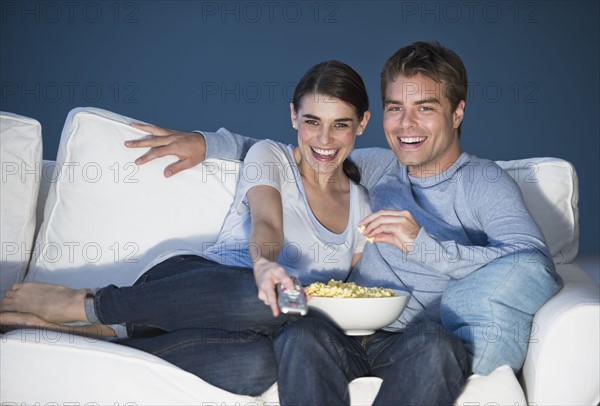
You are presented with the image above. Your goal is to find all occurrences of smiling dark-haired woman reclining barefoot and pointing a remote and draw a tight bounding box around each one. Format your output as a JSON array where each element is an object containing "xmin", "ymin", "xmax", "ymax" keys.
[{"xmin": 0, "ymin": 61, "xmax": 370, "ymax": 395}]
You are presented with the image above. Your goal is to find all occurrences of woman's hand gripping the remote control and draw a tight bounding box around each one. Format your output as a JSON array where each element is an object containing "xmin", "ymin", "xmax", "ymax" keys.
[{"xmin": 254, "ymin": 258, "xmax": 295, "ymax": 317}]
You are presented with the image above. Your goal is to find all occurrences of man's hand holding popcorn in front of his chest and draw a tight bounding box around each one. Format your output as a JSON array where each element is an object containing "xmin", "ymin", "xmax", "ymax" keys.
[{"xmin": 358, "ymin": 210, "xmax": 421, "ymax": 252}]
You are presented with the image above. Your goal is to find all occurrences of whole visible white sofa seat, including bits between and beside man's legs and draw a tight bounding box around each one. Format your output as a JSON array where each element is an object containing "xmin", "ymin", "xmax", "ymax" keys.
[{"xmin": 0, "ymin": 329, "xmax": 525, "ymax": 406}]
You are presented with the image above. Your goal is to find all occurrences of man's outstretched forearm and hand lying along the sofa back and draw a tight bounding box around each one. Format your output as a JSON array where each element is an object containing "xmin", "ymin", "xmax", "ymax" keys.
[{"xmin": 125, "ymin": 124, "xmax": 258, "ymax": 178}]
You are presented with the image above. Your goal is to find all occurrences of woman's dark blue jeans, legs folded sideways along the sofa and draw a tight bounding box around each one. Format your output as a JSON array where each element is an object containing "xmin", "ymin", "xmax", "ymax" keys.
[{"xmin": 94, "ymin": 255, "xmax": 289, "ymax": 396}]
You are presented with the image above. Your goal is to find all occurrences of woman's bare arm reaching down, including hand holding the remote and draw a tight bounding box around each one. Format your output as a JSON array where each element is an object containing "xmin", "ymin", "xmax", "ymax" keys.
[{"xmin": 246, "ymin": 185, "xmax": 294, "ymax": 317}]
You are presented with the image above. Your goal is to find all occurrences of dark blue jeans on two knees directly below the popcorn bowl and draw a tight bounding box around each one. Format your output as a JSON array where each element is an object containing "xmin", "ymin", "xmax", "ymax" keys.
[{"xmin": 274, "ymin": 316, "xmax": 470, "ymax": 406}]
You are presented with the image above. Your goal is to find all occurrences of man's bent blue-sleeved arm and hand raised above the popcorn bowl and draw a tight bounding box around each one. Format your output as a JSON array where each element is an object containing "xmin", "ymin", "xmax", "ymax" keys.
[{"xmin": 361, "ymin": 162, "xmax": 550, "ymax": 278}]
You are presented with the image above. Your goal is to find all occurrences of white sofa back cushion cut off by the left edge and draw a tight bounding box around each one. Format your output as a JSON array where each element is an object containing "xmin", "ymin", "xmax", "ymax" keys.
[{"xmin": 0, "ymin": 112, "xmax": 42, "ymax": 297}]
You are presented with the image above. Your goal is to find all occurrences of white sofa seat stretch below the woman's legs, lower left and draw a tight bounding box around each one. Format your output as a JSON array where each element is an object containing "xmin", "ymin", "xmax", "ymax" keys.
[{"xmin": 0, "ymin": 330, "xmax": 262, "ymax": 406}]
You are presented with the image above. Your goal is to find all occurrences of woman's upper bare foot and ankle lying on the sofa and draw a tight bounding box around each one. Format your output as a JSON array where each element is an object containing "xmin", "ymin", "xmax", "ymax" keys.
[{"xmin": 0, "ymin": 282, "xmax": 88, "ymax": 324}]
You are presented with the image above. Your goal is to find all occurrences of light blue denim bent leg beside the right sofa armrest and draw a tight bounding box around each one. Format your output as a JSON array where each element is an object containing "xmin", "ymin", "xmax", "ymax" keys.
[{"xmin": 441, "ymin": 250, "xmax": 562, "ymax": 375}]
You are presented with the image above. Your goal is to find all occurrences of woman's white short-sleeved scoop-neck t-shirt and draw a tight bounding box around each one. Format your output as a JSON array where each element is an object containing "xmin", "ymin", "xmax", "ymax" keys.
[{"xmin": 204, "ymin": 140, "xmax": 371, "ymax": 284}]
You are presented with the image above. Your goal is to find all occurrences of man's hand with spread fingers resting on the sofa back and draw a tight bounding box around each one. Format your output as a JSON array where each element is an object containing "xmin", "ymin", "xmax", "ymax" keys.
[{"xmin": 125, "ymin": 124, "xmax": 206, "ymax": 178}]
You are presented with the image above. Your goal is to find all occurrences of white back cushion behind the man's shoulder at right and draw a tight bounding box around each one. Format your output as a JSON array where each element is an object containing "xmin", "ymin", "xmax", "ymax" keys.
[{"xmin": 496, "ymin": 158, "xmax": 579, "ymax": 264}]
